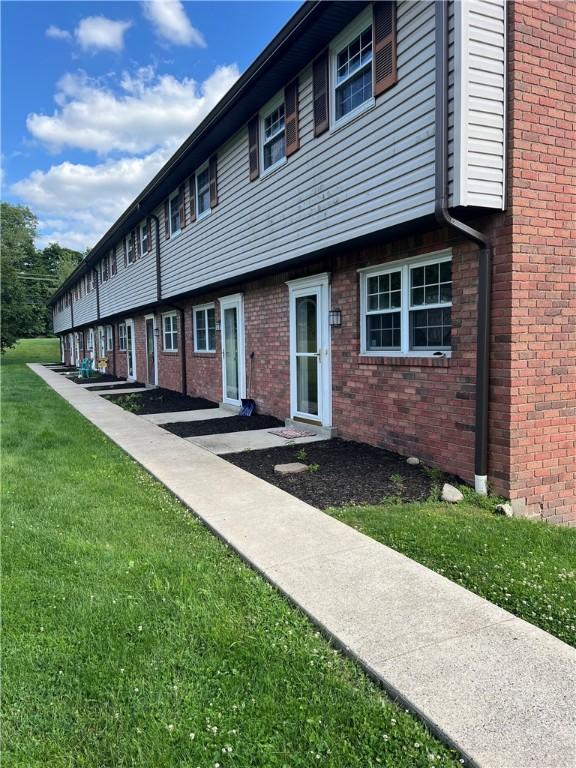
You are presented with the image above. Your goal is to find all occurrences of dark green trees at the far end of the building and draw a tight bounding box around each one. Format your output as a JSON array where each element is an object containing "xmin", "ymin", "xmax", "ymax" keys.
[{"xmin": 0, "ymin": 203, "xmax": 87, "ymax": 352}]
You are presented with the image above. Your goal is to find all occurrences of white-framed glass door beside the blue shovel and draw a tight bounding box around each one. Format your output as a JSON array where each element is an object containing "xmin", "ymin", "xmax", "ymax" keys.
[{"xmin": 220, "ymin": 293, "xmax": 246, "ymax": 405}]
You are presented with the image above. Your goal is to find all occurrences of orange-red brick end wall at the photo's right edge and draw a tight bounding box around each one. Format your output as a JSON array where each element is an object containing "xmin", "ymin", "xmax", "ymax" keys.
[{"xmin": 508, "ymin": 2, "xmax": 576, "ymax": 522}]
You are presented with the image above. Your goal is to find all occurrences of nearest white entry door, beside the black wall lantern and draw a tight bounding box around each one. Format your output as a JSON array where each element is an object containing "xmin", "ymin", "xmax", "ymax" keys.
[{"xmin": 288, "ymin": 274, "xmax": 332, "ymax": 427}]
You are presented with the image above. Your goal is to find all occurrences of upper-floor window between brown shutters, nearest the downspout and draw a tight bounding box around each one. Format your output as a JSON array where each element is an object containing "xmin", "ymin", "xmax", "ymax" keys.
[{"xmin": 330, "ymin": 7, "xmax": 375, "ymax": 126}]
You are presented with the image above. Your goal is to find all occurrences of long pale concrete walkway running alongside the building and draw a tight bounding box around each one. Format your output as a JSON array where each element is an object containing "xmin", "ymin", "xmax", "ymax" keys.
[{"xmin": 30, "ymin": 365, "xmax": 576, "ymax": 768}]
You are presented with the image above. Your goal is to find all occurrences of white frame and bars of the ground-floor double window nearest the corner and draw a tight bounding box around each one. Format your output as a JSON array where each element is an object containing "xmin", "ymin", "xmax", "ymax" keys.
[{"xmin": 358, "ymin": 250, "xmax": 454, "ymax": 357}]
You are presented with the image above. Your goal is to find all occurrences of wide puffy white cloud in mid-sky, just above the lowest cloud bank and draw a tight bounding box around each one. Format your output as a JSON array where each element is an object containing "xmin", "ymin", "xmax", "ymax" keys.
[{"xmin": 26, "ymin": 65, "xmax": 239, "ymax": 155}]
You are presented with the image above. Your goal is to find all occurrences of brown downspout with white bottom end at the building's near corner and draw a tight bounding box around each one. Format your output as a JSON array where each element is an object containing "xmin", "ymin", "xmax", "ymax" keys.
[{"xmin": 434, "ymin": 0, "xmax": 493, "ymax": 496}]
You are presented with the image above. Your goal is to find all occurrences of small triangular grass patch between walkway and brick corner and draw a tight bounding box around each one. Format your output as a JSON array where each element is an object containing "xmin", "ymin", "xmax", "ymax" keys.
[{"xmin": 328, "ymin": 488, "xmax": 576, "ymax": 645}]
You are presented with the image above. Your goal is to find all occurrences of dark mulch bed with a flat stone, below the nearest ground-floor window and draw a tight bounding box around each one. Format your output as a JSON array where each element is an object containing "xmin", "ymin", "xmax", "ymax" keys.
[{"xmin": 221, "ymin": 438, "xmax": 433, "ymax": 509}]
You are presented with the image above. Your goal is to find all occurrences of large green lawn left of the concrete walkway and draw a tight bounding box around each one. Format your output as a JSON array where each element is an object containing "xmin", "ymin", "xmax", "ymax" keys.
[{"xmin": 2, "ymin": 340, "xmax": 458, "ymax": 768}]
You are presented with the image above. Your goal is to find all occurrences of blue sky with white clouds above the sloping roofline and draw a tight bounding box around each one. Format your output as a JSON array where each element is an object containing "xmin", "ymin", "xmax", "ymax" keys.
[{"xmin": 1, "ymin": 0, "xmax": 300, "ymax": 250}]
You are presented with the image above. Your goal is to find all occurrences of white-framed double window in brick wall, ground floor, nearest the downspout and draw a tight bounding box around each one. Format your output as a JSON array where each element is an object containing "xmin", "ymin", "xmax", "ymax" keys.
[{"xmin": 360, "ymin": 251, "xmax": 452, "ymax": 357}]
